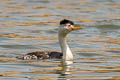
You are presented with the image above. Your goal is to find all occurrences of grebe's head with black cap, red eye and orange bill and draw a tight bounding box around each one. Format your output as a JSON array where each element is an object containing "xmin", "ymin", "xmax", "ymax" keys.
[{"xmin": 59, "ymin": 19, "xmax": 83, "ymax": 35}]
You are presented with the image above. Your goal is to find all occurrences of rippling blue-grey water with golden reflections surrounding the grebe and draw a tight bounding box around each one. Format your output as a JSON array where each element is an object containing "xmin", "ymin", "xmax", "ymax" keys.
[{"xmin": 0, "ymin": 0, "xmax": 120, "ymax": 80}]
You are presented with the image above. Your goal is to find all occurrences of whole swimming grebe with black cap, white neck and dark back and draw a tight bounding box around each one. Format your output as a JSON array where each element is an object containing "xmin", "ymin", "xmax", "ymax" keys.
[{"xmin": 17, "ymin": 19, "xmax": 84, "ymax": 60}]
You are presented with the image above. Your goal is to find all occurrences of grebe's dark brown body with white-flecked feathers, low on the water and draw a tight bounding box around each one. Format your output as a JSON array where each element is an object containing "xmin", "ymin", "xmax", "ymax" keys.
[{"xmin": 16, "ymin": 51, "xmax": 63, "ymax": 60}]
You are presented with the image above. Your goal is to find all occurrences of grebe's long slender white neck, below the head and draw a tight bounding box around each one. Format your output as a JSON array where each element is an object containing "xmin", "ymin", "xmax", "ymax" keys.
[{"xmin": 58, "ymin": 32, "xmax": 73, "ymax": 61}]
